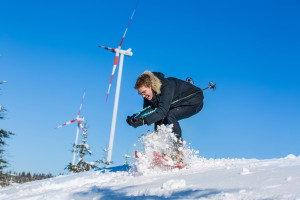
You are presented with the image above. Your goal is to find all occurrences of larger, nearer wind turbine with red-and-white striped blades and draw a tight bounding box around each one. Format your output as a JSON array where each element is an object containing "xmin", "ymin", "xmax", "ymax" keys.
[{"xmin": 99, "ymin": 7, "xmax": 136, "ymax": 163}]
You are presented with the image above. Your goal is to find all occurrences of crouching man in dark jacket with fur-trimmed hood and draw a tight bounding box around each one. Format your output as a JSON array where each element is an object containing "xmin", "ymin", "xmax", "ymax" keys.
[{"xmin": 126, "ymin": 71, "xmax": 204, "ymax": 141}]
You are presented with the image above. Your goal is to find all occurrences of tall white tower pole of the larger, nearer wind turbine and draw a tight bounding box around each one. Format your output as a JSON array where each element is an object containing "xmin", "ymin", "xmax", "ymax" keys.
[{"xmin": 107, "ymin": 53, "xmax": 124, "ymax": 166}]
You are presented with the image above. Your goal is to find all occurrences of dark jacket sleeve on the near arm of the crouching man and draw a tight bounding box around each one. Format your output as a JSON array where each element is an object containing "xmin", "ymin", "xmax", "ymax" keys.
[{"xmin": 144, "ymin": 80, "xmax": 175, "ymax": 125}]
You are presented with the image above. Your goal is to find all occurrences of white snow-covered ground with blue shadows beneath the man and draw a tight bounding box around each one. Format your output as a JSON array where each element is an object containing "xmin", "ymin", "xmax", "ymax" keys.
[{"xmin": 0, "ymin": 127, "xmax": 300, "ymax": 200}]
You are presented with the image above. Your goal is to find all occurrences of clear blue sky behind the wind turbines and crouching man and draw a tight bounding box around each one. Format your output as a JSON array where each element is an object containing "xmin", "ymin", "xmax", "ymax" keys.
[{"xmin": 0, "ymin": 0, "xmax": 300, "ymax": 174}]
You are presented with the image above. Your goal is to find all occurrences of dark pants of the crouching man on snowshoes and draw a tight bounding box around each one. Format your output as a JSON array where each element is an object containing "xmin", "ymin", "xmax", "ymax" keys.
[{"xmin": 155, "ymin": 102, "xmax": 203, "ymax": 141}]
